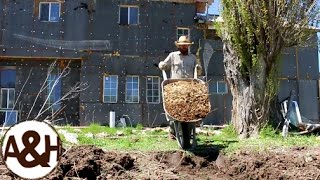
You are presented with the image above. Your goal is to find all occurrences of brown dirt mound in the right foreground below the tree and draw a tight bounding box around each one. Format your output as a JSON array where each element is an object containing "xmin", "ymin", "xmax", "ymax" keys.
[{"xmin": 217, "ymin": 148, "xmax": 320, "ymax": 179}]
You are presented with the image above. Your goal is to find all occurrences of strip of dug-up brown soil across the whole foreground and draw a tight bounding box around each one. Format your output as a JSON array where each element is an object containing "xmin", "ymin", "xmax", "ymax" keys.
[{"xmin": 0, "ymin": 146, "xmax": 320, "ymax": 180}]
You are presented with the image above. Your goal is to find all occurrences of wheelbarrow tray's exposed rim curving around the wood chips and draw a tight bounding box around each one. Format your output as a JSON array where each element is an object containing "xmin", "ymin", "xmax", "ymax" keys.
[{"xmin": 161, "ymin": 78, "xmax": 209, "ymax": 122}]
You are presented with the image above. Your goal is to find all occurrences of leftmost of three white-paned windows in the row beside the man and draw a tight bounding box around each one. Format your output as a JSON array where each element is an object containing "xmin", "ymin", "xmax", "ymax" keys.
[{"xmin": 103, "ymin": 75, "xmax": 118, "ymax": 103}]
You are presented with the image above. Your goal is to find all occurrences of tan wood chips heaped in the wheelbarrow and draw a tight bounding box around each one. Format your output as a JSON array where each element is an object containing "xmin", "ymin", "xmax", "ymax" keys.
[{"xmin": 163, "ymin": 81, "xmax": 211, "ymax": 121}]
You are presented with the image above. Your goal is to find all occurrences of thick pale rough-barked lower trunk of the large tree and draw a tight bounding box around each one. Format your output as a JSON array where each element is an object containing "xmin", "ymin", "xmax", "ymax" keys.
[{"xmin": 223, "ymin": 41, "xmax": 272, "ymax": 138}]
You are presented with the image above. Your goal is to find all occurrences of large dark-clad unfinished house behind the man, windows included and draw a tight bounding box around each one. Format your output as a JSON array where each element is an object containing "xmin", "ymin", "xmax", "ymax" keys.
[{"xmin": 0, "ymin": 0, "xmax": 319, "ymax": 126}]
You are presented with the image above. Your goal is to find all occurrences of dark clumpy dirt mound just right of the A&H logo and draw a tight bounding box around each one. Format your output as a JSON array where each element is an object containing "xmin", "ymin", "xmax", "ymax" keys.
[{"xmin": 48, "ymin": 146, "xmax": 134, "ymax": 179}]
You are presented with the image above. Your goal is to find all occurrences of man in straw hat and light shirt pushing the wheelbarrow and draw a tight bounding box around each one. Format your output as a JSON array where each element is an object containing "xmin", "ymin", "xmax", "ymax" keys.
[{"xmin": 159, "ymin": 36, "xmax": 202, "ymax": 139}]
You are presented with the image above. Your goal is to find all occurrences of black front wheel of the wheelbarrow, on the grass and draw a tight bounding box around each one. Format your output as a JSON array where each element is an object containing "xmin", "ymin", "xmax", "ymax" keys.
[{"xmin": 175, "ymin": 121, "xmax": 196, "ymax": 149}]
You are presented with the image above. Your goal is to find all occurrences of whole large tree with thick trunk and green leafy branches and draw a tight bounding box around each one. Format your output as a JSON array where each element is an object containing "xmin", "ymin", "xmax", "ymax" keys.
[{"xmin": 216, "ymin": 0, "xmax": 318, "ymax": 138}]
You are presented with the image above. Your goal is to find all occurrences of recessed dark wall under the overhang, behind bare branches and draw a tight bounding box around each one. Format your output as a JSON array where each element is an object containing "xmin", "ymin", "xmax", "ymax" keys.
[{"xmin": 0, "ymin": 59, "xmax": 80, "ymax": 125}]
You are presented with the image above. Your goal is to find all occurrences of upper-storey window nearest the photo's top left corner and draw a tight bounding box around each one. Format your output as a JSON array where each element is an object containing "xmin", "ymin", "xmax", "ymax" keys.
[{"xmin": 39, "ymin": 2, "xmax": 60, "ymax": 22}]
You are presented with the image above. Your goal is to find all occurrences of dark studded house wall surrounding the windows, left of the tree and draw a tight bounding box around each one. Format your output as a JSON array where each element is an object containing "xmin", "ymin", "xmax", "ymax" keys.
[{"xmin": 0, "ymin": 0, "xmax": 203, "ymax": 126}]
